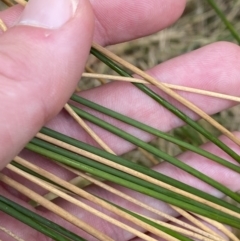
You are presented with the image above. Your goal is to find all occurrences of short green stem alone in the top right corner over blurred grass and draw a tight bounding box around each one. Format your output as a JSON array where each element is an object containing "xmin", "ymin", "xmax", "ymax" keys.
[{"xmin": 207, "ymin": 0, "xmax": 240, "ymax": 44}]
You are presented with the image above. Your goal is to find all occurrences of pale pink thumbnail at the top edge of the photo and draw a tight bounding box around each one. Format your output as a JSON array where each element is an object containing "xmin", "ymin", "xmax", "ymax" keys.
[{"xmin": 18, "ymin": 0, "xmax": 79, "ymax": 29}]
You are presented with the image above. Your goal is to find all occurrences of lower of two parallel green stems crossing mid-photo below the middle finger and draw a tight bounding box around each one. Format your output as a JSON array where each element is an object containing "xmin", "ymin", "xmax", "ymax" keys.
[{"xmin": 68, "ymin": 106, "xmax": 240, "ymax": 202}]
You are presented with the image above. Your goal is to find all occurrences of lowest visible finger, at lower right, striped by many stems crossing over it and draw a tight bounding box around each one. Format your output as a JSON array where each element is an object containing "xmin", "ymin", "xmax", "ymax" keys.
[{"xmin": 4, "ymin": 133, "xmax": 240, "ymax": 241}]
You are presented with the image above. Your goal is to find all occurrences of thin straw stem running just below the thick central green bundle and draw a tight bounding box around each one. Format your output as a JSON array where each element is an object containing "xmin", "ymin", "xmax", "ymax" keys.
[{"xmin": 60, "ymin": 164, "xmax": 223, "ymax": 240}]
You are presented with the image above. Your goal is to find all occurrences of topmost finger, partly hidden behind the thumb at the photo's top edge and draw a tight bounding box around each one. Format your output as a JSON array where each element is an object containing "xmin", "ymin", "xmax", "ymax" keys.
[{"xmin": 0, "ymin": 0, "xmax": 186, "ymax": 45}]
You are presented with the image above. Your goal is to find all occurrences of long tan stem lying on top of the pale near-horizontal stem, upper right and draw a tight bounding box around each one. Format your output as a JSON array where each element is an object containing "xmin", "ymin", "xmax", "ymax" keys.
[{"xmin": 92, "ymin": 43, "xmax": 240, "ymax": 145}]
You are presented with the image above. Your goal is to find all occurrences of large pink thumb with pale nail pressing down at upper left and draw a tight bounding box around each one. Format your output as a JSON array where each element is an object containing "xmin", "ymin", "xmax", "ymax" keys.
[{"xmin": 0, "ymin": 0, "xmax": 94, "ymax": 169}]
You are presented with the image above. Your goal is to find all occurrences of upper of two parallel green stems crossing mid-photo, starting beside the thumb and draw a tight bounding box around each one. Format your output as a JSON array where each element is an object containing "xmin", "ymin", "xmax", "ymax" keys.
[{"xmin": 71, "ymin": 94, "xmax": 240, "ymax": 173}]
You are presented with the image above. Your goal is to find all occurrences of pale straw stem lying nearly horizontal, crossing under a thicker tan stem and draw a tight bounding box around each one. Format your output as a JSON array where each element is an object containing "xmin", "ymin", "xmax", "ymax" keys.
[{"xmin": 82, "ymin": 73, "xmax": 240, "ymax": 102}]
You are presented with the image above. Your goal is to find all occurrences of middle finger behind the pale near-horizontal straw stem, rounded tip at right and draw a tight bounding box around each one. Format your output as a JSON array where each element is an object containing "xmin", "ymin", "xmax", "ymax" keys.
[{"xmin": 46, "ymin": 42, "xmax": 240, "ymax": 154}]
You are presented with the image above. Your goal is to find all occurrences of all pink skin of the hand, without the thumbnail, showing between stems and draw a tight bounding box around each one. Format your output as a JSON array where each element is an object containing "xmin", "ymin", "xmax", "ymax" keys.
[{"xmin": 0, "ymin": 0, "xmax": 240, "ymax": 241}]
